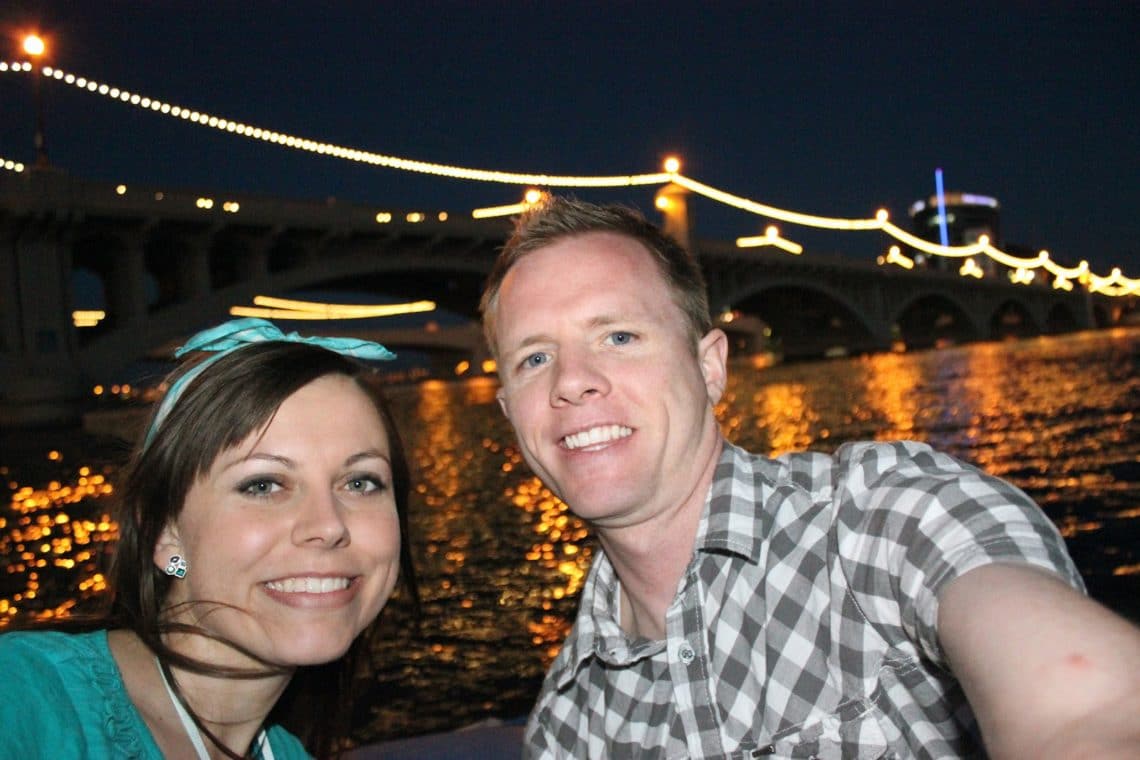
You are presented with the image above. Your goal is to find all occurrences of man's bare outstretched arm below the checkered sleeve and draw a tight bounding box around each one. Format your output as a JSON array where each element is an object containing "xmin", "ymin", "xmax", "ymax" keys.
[{"xmin": 938, "ymin": 564, "xmax": 1140, "ymax": 760}]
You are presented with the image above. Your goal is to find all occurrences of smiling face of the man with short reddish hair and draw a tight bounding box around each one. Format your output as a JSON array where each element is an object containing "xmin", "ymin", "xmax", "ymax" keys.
[{"xmin": 496, "ymin": 232, "xmax": 726, "ymax": 529}]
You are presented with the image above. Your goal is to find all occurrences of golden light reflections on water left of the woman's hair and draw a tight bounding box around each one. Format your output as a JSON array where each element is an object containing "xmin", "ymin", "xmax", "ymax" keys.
[{"xmin": 0, "ymin": 460, "xmax": 119, "ymax": 627}]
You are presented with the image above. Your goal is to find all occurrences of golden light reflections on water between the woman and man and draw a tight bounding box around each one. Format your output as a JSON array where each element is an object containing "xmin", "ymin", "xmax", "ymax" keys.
[{"xmin": 406, "ymin": 377, "xmax": 592, "ymax": 667}]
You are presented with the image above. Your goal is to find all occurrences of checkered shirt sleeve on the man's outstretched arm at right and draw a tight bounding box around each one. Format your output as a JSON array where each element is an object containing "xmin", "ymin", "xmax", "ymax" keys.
[{"xmin": 834, "ymin": 442, "xmax": 1084, "ymax": 663}]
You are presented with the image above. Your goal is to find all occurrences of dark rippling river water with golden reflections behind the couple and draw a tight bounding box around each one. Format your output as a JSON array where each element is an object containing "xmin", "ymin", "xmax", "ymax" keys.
[{"xmin": 0, "ymin": 329, "xmax": 1140, "ymax": 742}]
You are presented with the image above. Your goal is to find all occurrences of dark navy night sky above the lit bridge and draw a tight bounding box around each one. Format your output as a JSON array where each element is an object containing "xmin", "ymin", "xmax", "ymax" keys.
[{"xmin": 0, "ymin": 0, "xmax": 1140, "ymax": 277}]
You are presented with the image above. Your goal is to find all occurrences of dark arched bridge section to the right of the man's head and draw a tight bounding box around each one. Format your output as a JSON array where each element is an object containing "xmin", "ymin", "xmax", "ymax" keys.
[{"xmin": 697, "ymin": 242, "xmax": 1121, "ymax": 358}]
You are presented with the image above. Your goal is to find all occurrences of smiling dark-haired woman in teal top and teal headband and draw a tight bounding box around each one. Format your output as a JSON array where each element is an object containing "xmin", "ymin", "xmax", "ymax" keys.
[{"xmin": 0, "ymin": 319, "xmax": 416, "ymax": 760}]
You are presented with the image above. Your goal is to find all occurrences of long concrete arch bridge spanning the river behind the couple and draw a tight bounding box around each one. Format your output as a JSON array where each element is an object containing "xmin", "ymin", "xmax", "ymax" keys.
[{"xmin": 0, "ymin": 170, "xmax": 1118, "ymax": 424}]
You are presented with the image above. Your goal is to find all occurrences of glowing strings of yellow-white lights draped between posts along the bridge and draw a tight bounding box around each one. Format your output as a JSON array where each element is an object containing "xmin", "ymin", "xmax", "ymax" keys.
[{"xmin": 0, "ymin": 62, "xmax": 1140, "ymax": 296}]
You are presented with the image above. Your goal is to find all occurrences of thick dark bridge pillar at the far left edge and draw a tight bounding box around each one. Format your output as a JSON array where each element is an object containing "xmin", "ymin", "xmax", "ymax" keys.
[{"xmin": 0, "ymin": 221, "xmax": 86, "ymax": 426}]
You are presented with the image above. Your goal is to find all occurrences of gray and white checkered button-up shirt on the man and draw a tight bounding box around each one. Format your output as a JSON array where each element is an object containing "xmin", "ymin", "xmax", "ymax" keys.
[{"xmin": 524, "ymin": 442, "xmax": 1084, "ymax": 760}]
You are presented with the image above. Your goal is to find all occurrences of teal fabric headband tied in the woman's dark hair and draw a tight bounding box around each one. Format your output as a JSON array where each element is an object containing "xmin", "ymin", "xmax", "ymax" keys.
[{"xmin": 143, "ymin": 318, "xmax": 396, "ymax": 449}]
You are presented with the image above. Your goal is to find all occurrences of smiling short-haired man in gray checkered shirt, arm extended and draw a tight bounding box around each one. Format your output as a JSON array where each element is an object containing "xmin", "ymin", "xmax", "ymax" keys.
[{"xmin": 482, "ymin": 198, "xmax": 1140, "ymax": 758}]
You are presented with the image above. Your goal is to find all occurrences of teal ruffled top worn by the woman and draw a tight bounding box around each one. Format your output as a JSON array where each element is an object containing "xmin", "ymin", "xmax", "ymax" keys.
[{"xmin": 0, "ymin": 630, "xmax": 309, "ymax": 760}]
